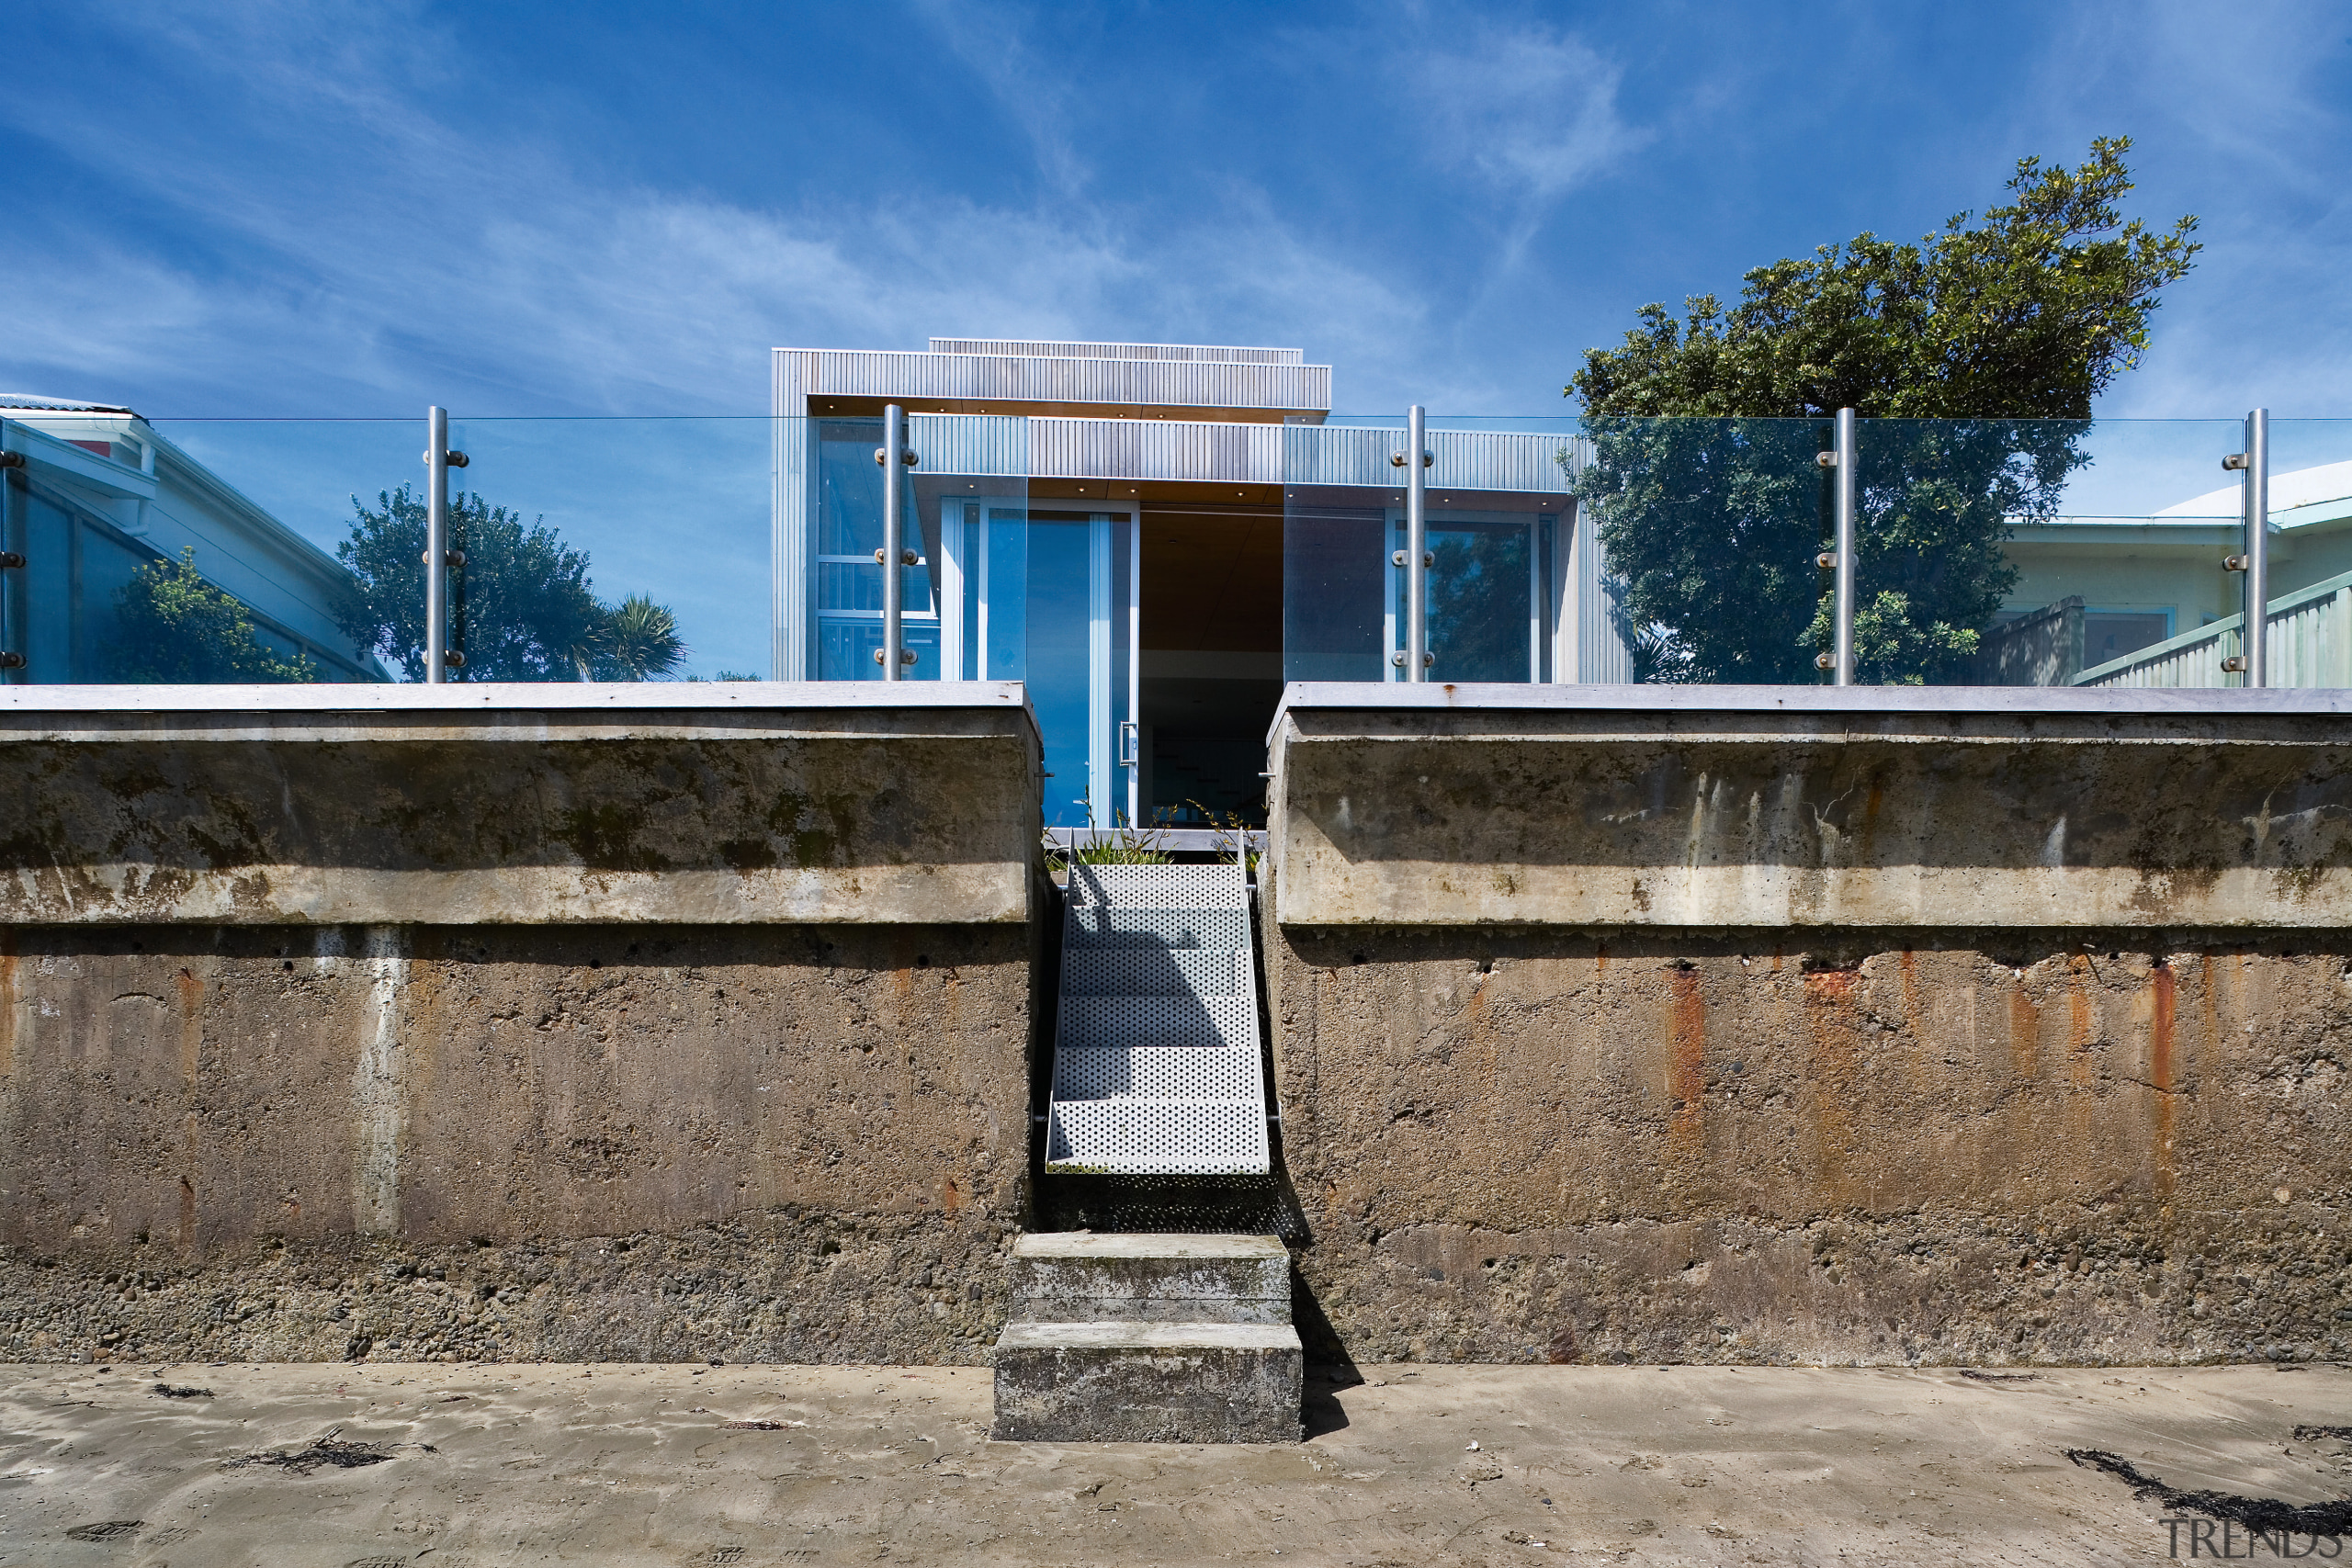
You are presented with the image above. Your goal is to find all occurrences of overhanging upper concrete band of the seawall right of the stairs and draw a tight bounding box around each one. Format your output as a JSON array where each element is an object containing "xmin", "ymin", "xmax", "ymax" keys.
[{"xmin": 1270, "ymin": 686, "xmax": 2352, "ymax": 931}]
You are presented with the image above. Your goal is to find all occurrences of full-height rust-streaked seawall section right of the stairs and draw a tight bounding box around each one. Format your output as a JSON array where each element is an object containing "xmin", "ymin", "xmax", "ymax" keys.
[{"xmin": 1263, "ymin": 689, "xmax": 2352, "ymax": 1361}]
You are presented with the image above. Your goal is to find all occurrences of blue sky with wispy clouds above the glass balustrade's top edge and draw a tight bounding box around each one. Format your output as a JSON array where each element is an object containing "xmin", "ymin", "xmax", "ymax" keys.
[{"xmin": 0, "ymin": 0, "xmax": 2352, "ymax": 416}]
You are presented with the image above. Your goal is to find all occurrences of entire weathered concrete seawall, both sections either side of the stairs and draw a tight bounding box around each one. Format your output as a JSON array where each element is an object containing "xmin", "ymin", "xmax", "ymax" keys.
[{"xmin": 18, "ymin": 684, "xmax": 2352, "ymax": 1363}]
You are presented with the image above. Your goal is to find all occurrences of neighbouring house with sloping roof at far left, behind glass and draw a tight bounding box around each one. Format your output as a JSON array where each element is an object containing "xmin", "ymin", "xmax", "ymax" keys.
[{"xmin": 0, "ymin": 392, "xmax": 383, "ymax": 684}]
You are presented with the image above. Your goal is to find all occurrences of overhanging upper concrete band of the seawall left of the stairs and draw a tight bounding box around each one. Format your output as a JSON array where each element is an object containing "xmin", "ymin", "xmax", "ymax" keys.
[{"xmin": 0, "ymin": 682, "xmax": 1037, "ymax": 924}]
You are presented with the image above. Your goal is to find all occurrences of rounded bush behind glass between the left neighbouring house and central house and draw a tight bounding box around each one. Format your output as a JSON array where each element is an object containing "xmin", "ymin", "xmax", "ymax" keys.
[{"xmin": 336, "ymin": 484, "xmax": 687, "ymax": 682}]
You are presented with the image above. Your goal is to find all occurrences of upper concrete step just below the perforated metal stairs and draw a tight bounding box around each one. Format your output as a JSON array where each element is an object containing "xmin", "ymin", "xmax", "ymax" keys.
[{"xmin": 1012, "ymin": 1229, "xmax": 1291, "ymax": 1324}]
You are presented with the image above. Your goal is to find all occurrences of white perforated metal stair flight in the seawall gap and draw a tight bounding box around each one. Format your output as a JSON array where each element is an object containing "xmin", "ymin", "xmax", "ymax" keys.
[{"xmin": 1045, "ymin": 865, "xmax": 1270, "ymax": 1176}]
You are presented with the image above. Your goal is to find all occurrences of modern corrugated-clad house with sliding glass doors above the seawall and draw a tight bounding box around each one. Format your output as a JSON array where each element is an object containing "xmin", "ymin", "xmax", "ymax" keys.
[{"xmin": 772, "ymin": 339, "xmax": 1630, "ymax": 828}]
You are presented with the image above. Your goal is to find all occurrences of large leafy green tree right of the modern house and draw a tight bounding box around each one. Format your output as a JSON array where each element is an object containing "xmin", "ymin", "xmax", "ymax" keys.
[{"xmin": 1566, "ymin": 136, "xmax": 2199, "ymax": 682}]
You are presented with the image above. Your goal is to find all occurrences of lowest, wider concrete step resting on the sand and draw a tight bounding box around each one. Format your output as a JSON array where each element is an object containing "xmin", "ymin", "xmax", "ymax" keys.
[{"xmin": 988, "ymin": 1324, "xmax": 1306, "ymax": 1443}]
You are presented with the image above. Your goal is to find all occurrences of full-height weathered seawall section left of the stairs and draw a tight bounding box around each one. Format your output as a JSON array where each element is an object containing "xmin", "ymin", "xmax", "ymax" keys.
[{"xmin": 0, "ymin": 686, "xmax": 1040, "ymax": 1361}]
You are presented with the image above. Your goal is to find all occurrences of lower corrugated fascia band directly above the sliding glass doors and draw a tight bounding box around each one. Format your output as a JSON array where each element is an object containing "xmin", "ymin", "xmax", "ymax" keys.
[{"xmin": 908, "ymin": 413, "xmax": 1588, "ymax": 493}]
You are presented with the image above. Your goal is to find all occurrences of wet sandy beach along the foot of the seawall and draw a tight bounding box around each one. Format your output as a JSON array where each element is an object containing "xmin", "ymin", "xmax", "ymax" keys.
[{"xmin": 0, "ymin": 1363, "xmax": 2352, "ymax": 1568}]
